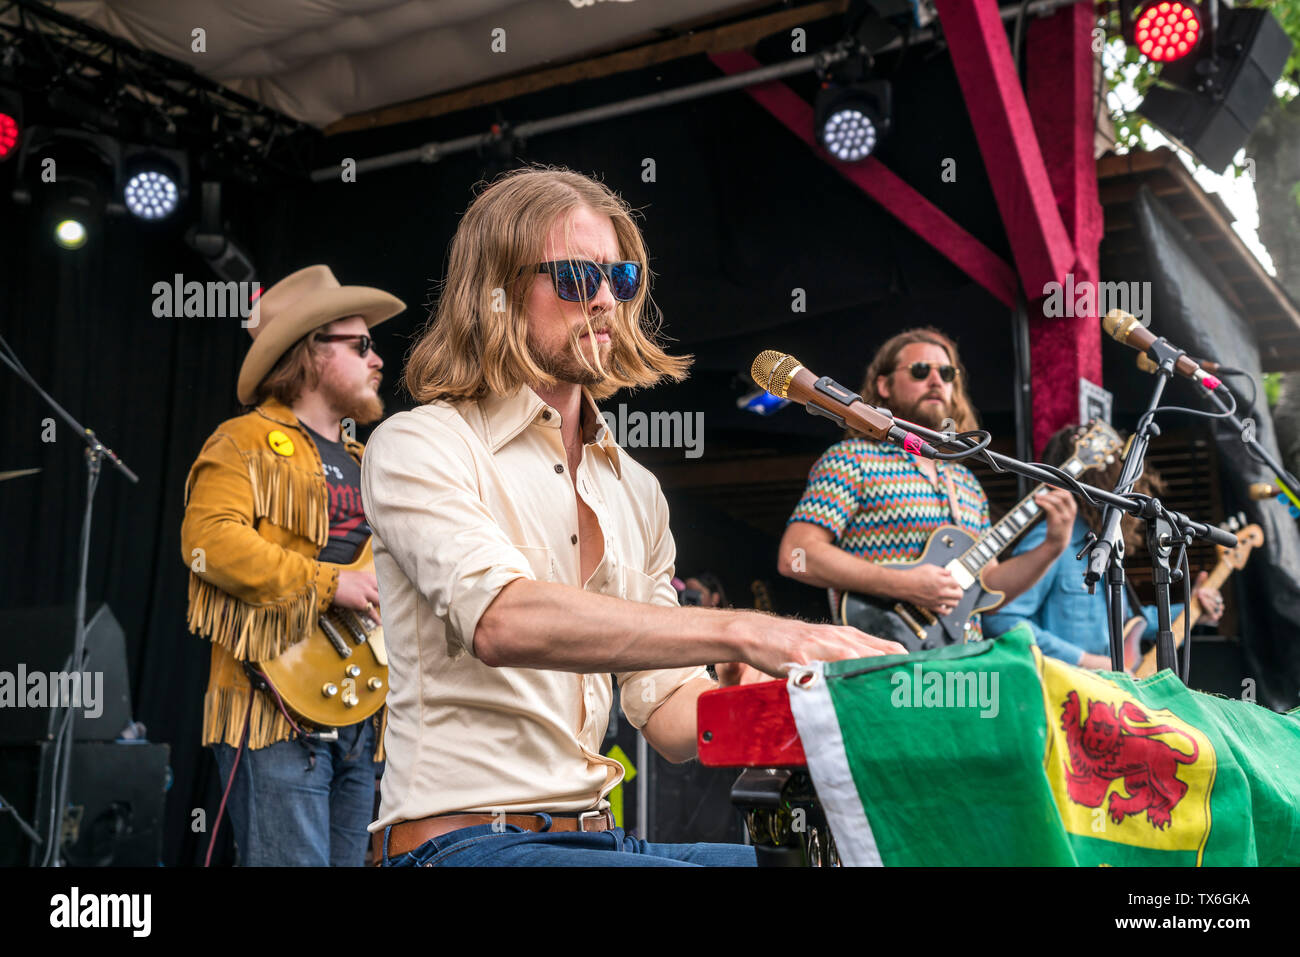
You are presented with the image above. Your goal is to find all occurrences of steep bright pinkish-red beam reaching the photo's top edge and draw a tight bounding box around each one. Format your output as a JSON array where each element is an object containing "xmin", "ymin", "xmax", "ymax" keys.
[{"xmin": 935, "ymin": 0, "xmax": 1076, "ymax": 300}]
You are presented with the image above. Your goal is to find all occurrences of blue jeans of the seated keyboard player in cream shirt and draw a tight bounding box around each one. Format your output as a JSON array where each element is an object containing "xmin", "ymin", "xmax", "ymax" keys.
[{"xmin": 384, "ymin": 814, "xmax": 755, "ymax": 867}]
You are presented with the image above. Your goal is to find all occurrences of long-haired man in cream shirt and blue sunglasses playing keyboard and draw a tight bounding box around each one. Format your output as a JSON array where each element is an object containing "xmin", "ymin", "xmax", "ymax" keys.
[{"xmin": 361, "ymin": 168, "xmax": 902, "ymax": 866}]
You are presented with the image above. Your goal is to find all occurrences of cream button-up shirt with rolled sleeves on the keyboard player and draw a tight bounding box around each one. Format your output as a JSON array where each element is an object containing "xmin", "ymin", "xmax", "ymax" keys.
[{"xmin": 361, "ymin": 387, "xmax": 705, "ymax": 831}]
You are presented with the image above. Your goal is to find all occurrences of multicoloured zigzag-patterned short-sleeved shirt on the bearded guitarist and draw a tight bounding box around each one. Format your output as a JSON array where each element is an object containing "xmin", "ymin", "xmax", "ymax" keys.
[{"xmin": 785, "ymin": 438, "xmax": 989, "ymax": 636}]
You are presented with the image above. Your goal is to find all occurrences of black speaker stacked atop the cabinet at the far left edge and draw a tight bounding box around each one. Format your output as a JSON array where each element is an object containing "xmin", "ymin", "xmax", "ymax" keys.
[{"xmin": 0, "ymin": 603, "xmax": 131, "ymax": 743}]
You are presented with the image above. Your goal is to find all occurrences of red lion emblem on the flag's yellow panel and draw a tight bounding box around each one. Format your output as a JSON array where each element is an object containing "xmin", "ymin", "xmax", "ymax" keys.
[{"xmin": 1061, "ymin": 692, "xmax": 1200, "ymax": 828}]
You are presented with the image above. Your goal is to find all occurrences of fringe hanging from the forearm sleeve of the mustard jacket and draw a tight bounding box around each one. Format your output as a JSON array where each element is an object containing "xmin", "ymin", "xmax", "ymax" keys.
[{"xmin": 189, "ymin": 572, "xmax": 320, "ymax": 662}]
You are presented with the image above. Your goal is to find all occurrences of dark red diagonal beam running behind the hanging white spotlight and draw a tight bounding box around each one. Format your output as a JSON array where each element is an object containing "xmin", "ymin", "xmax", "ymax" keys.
[{"xmin": 710, "ymin": 52, "xmax": 1019, "ymax": 306}]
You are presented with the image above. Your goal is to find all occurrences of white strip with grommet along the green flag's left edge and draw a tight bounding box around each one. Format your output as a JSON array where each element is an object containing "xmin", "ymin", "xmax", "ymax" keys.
[{"xmin": 787, "ymin": 662, "xmax": 883, "ymax": 867}]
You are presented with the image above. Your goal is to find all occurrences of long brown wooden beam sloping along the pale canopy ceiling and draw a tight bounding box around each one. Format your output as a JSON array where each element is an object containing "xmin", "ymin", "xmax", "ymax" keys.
[{"xmin": 325, "ymin": 0, "xmax": 849, "ymax": 137}]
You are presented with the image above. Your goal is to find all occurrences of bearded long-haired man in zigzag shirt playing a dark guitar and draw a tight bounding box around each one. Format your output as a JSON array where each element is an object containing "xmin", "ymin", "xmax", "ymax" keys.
[{"xmin": 777, "ymin": 328, "xmax": 1075, "ymax": 638}]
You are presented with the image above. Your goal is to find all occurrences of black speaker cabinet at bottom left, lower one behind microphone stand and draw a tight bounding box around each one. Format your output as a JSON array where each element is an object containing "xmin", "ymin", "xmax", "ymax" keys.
[{"xmin": 0, "ymin": 741, "xmax": 170, "ymax": 867}]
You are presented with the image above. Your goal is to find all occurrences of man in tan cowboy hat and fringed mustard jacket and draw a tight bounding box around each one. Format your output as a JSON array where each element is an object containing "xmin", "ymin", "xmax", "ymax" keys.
[{"xmin": 181, "ymin": 265, "xmax": 406, "ymax": 866}]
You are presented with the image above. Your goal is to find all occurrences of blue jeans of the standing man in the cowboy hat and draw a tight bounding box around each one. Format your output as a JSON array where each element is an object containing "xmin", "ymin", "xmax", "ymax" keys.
[{"xmin": 212, "ymin": 720, "xmax": 377, "ymax": 867}]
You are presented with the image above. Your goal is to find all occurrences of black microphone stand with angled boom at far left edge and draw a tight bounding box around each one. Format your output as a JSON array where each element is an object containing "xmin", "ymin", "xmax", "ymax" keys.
[{"xmin": 0, "ymin": 337, "xmax": 139, "ymax": 867}]
